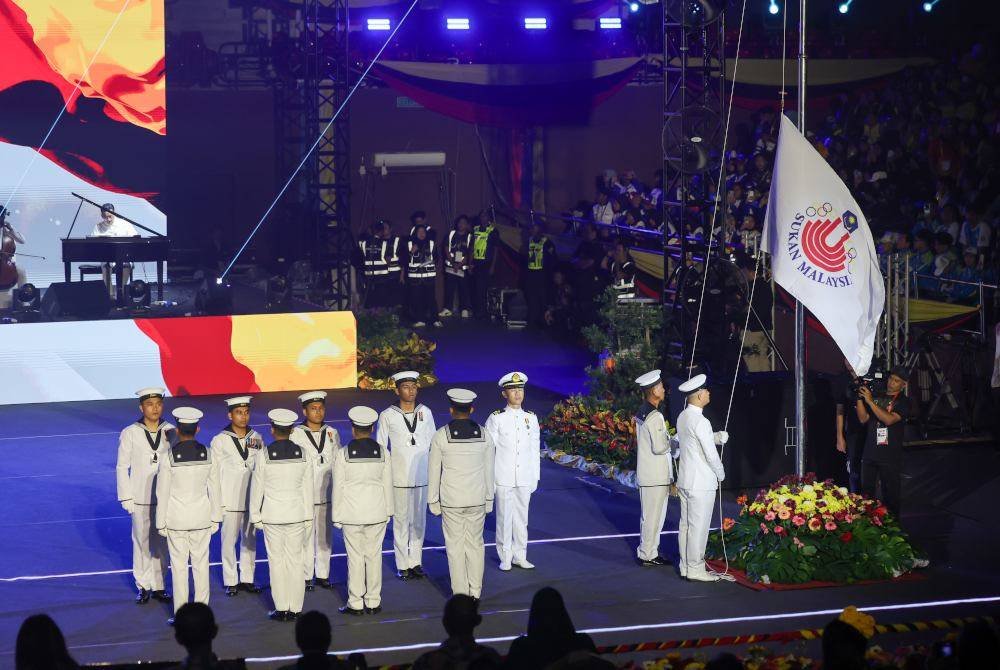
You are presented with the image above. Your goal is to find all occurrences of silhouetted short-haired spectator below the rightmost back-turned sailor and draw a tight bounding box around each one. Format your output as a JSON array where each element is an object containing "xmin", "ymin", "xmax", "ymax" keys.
[{"xmin": 413, "ymin": 593, "xmax": 501, "ymax": 670}]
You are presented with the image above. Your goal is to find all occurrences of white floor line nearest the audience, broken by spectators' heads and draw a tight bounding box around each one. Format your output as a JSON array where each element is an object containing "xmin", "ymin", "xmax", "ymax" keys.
[{"xmin": 245, "ymin": 596, "xmax": 1000, "ymax": 663}]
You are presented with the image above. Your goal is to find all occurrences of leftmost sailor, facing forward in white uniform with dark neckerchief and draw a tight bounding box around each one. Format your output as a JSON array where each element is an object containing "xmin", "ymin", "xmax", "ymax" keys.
[{"xmin": 115, "ymin": 388, "xmax": 174, "ymax": 605}]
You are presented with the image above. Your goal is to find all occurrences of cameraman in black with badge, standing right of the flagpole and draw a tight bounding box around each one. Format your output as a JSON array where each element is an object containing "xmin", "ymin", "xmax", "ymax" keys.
[{"xmin": 855, "ymin": 366, "xmax": 909, "ymax": 520}]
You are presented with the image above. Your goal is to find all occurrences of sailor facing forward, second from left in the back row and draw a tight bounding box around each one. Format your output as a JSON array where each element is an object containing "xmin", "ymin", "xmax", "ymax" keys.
[{"xmin": 209, "ymin": 396, "xmax": 264, "ymax": 596}]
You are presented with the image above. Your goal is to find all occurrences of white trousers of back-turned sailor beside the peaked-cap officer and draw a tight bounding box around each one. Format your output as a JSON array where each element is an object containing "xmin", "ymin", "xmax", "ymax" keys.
[{"xmin": 441, "ymin": 505, "xmax": 486, "ymax": 598}]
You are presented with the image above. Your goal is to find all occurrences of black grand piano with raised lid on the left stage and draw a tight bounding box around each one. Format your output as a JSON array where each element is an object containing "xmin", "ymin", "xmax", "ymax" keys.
[{"xmin": 62, "ymin": 193, "xmax": 170, "ymax": 300}]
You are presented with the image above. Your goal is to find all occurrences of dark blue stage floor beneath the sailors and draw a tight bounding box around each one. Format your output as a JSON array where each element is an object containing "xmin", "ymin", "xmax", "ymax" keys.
[{"xmin": 0, "ymin": 330, "xmax": 1000, "ymax": 667}]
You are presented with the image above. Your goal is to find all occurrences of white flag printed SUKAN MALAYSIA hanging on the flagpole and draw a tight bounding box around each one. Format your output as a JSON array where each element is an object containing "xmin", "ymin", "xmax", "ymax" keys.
[{"xmin": 763, "ymin": 115, "xmax": 885, "ymax": 375}]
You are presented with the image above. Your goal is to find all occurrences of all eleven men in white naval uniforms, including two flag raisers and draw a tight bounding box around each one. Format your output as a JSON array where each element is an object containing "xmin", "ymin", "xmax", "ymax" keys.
[{"xmin": 116, "ymin": 370, "xmax": 728, "ymax": 624}]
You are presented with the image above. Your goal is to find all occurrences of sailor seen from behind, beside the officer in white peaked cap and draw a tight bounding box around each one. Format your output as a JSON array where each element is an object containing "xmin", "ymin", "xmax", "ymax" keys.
[{"xmin": 427, "ymin": 389, "xmax": 495, "ymax": 600}]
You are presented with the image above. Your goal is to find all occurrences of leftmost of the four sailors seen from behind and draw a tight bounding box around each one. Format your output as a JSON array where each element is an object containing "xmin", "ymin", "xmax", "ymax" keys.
[{"xmin": 156, "ymin": 407, "xmax": 222, "ymax": 625}]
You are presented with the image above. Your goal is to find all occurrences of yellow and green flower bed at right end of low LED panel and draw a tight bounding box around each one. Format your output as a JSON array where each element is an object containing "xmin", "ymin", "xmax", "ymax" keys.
[{"xmin": 355, "ymin": 310, "xmax": 437, "ymax": 391}]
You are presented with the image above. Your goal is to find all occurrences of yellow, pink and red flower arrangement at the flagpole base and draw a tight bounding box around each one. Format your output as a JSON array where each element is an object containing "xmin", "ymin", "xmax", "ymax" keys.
[{"xmin": 707, "ymin": 473, "xmax": 915, "ymax": 584}]
